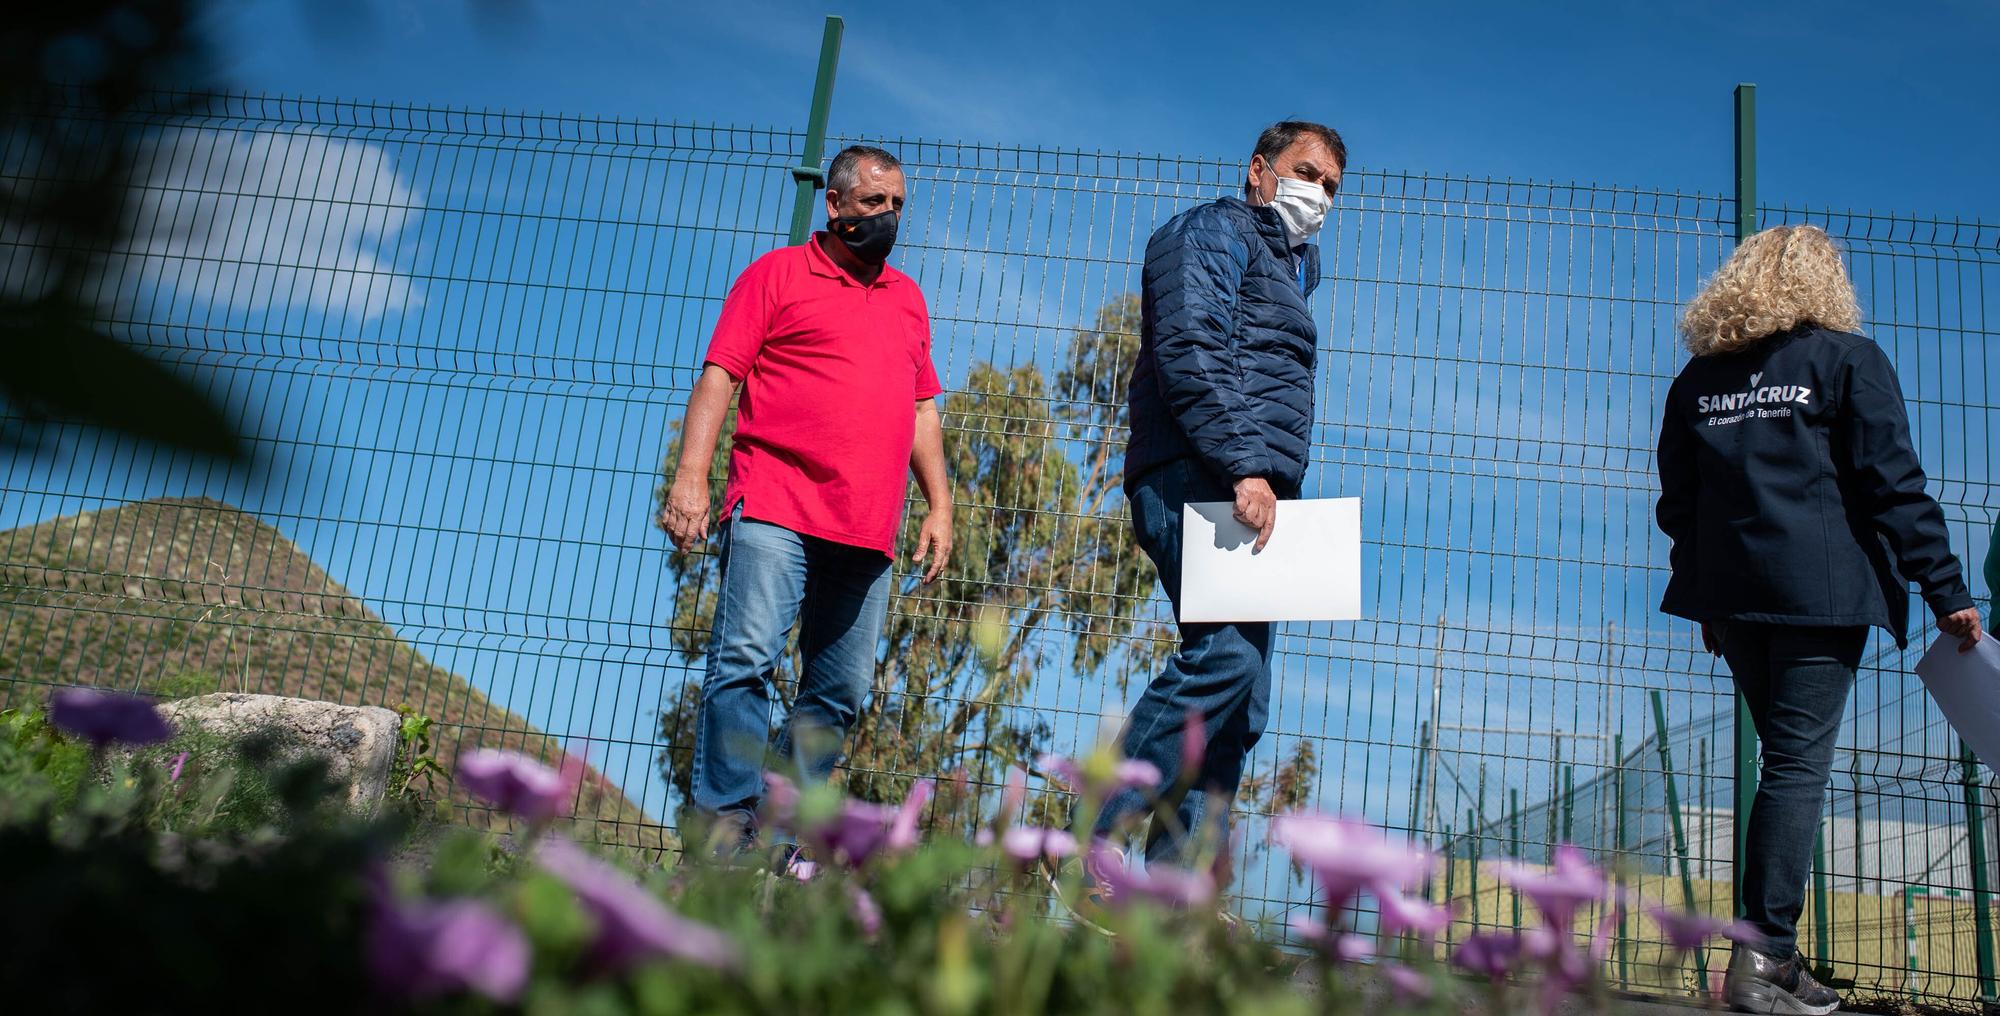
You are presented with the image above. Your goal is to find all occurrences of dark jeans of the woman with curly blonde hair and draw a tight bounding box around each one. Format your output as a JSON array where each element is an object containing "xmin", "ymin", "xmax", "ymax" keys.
[{"xmin": 1716, "ymin": 622, "xmax": 1868, "ymax": 958}]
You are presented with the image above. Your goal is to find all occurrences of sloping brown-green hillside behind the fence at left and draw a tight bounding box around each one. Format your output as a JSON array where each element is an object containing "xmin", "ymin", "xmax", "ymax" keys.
[{"xmin": 0, "ymin": 498, "xmax": 676, "ymax": 850}]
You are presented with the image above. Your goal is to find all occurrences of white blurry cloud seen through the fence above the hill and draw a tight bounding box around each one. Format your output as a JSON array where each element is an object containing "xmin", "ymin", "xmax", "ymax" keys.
[{"xmin": 128, "ymin": 128, "xmax": 422, "ymax": 320}]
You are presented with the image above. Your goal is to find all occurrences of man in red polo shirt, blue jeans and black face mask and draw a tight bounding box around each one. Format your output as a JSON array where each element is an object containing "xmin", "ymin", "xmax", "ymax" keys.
[{"xmin": 660, "ymin": 146, "xmax": 952, "ymax": 852}]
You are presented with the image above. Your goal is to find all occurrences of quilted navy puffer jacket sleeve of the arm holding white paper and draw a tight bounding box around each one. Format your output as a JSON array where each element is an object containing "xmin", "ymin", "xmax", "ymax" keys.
[{"xmin": 1144, "ymin": 222, "xmax": 1272, "ymax": 480}]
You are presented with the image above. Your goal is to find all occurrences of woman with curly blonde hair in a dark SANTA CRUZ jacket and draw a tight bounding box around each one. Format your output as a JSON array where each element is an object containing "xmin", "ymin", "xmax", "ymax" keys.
[{"xmin": 1660, "ymin": 226, "xmax": 1980, "ymax": 1014}]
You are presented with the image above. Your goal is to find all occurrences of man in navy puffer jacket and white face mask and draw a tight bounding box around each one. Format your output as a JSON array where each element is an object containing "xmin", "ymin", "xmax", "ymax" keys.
[{"xmin": 1098, "ymin": 120, "xmax": 1348, "ymax": 862}]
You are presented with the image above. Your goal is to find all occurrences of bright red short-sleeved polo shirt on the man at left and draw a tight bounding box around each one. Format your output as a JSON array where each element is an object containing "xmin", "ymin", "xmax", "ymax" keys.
[{"xmin": 708, "ymin": 236, "xmax": 940, "ymax": 556}]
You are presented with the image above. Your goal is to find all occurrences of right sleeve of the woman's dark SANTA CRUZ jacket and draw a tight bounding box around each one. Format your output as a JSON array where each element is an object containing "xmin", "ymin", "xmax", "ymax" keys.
[{"xmin": 1834, "ymin": 342, "xmax": 1972, "ymax": 618}]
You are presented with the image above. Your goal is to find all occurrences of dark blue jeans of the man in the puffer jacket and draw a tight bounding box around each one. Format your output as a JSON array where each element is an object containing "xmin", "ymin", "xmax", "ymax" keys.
[{"xmin": 1098, "ymin": 460, "xmax": 1272, "ymax": 862}]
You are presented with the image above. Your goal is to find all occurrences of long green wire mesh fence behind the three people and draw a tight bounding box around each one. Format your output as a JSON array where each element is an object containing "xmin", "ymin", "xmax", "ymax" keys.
[{"xmin": 0, "ymin": 98, "xmax": 2000, "ymax": 1004}]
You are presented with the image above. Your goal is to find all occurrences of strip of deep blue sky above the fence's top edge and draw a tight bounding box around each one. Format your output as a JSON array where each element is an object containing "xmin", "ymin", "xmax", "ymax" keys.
[{"xmin": 216, "ymin": 0, "xmax": 2000, "ymax": 220}]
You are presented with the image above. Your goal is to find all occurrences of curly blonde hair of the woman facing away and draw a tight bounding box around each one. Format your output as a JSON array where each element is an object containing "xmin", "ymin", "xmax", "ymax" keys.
[{"xmin": 1680, "ymin": 226, "xmax": 1862, "ymax": 356}]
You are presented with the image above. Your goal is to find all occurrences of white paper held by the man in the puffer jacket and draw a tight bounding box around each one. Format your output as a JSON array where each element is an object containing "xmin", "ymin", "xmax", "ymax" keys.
[{"xmin": 1180, "ymin": 498, "xmax": 1362, "ymax": 622}]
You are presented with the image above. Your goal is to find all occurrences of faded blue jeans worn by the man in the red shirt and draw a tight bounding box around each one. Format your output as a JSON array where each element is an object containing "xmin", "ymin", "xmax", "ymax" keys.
[{"xmin": 692, "ymin": 510, "xmax": 890, "ymax": 834}]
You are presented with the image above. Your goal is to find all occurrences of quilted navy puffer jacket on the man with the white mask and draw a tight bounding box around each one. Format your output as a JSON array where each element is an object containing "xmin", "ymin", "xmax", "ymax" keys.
[{"xmin": 1126, "ymin": 198, "xmax": 1320, "ymax": 498}]
